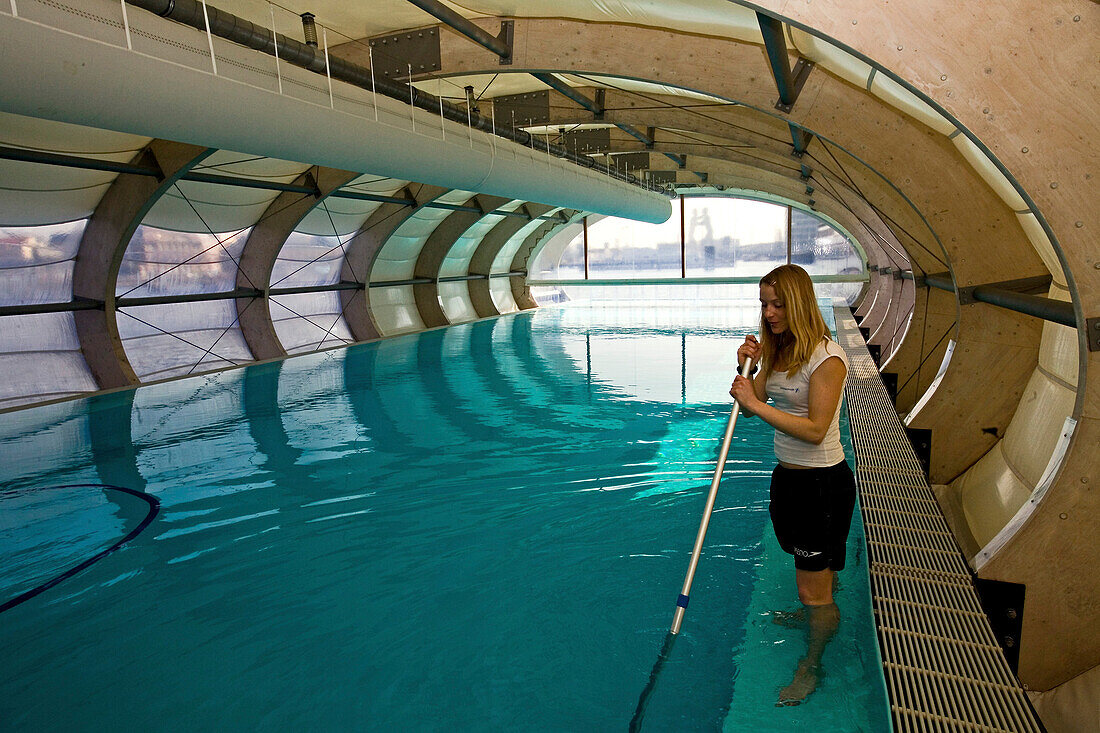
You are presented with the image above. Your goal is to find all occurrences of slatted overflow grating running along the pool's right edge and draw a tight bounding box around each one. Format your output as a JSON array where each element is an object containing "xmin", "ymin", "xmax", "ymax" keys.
[{"xmin": 835, "ymin": 308, "xmax": 1043, "ymax": 733}]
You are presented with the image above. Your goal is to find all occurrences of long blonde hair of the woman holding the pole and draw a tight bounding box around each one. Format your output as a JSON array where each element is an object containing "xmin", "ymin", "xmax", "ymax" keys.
[{"xmin": 760, "ymin": 264, "xmax": 828, "ymax": 376}]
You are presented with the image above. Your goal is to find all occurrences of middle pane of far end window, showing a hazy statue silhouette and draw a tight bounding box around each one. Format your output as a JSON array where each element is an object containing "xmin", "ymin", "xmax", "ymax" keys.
[{"xmin": 677, "ymin": 198, "xmax": 787, "ymax": 277}]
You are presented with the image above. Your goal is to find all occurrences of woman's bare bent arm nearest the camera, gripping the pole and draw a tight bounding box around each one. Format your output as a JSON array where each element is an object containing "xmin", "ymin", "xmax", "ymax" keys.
[{"xmin": 729, "ymin": 357, "xmax": 847, "ymax": 445}]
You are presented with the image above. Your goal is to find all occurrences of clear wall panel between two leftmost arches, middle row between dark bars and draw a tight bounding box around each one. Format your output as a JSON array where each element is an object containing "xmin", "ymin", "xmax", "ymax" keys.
[{"xmin": 114, "ymin": 226, "xmax": 250, "ymax": 297}]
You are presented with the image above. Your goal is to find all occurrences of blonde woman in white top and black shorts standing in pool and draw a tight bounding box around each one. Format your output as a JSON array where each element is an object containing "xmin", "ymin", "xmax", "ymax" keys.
[{"xmin": 729, "ymin": 265, "xmax": 856, "ymax": 704}]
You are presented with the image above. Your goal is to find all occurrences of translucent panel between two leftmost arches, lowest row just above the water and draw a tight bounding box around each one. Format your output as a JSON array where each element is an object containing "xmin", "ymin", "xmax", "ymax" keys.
[{"xmin": 118, "ymin": 299, "xmax": 253, "ymax": 382}]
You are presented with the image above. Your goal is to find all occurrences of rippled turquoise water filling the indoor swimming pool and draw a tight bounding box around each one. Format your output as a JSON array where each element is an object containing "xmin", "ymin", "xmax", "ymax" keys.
[{"xmin": 0, "ymin": 299, "xmax": 889, "ymax": 733}]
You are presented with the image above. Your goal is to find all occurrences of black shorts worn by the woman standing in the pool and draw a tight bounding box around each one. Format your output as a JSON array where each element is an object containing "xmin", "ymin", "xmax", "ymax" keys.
[{"xmin": 768, "ymin": 461, "xmax": 856, "ymax": 570}]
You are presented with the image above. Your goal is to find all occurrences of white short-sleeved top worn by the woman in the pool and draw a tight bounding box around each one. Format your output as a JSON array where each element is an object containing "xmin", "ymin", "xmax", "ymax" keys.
[{"xmin": 765, "ymin": 339, "xmax": 848, "ymax": 468}]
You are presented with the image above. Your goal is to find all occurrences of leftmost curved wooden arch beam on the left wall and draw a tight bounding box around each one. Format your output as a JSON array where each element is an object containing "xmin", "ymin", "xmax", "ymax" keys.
[{"xmin": 73, "ymin": 140, "xmax": 215, "ymax": 390}]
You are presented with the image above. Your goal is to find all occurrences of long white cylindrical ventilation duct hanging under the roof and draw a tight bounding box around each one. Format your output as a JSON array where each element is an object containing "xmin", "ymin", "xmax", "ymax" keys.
[{"xmin": 0, "ymin": 0, "xmax": 672, "ymax": 223}]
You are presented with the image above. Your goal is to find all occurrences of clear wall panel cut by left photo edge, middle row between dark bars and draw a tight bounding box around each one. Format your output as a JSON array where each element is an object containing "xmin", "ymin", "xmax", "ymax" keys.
[{"xmin": 0, "ymin": 219, "xmax": 88, "ymax": 305}]
